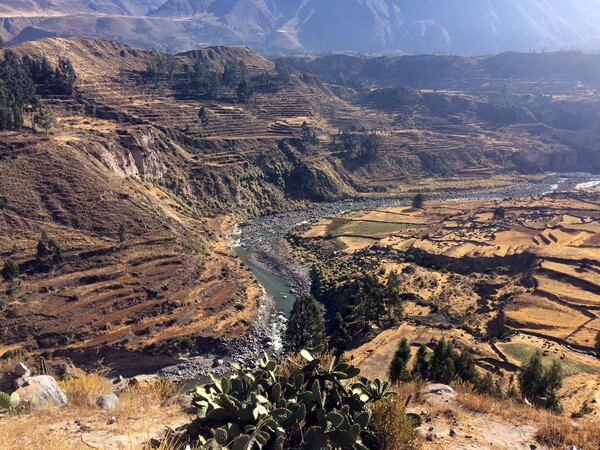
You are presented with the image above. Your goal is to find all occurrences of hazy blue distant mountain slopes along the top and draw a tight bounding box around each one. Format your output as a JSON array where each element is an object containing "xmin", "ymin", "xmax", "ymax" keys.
[{"xmin": 0, "ymin": 0, "xmax": 600, "ymax": 54}]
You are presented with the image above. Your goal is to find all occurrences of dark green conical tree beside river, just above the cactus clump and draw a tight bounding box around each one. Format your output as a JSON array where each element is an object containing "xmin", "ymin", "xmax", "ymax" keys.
[{"xmin": 285, "ymin": 295, "xmax": 325, "ymax": 352}]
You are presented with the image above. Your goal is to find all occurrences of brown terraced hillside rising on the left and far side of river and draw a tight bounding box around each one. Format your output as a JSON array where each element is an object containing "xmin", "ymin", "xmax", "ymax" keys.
[{"xmin": 0, "ymin": 39, "xmax": 598, "ymax": 369}]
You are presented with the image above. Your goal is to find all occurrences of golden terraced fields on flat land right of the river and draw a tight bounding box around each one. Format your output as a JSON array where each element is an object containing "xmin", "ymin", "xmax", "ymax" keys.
[{"xmin": 302, "ymin": 191, "xmax": 600, "ymax": 400}]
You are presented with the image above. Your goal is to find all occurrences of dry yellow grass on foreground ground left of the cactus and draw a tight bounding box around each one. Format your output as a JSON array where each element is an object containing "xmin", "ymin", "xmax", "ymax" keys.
[{"xmin": 0, "ymin": 373, "xmax": 186, "ymax": 450}]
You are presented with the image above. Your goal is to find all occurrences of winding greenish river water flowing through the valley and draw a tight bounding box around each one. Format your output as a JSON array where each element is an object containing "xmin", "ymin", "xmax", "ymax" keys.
[{"xmin": 231, "ymin": 173, "xmax": 600, "ymax": 354}]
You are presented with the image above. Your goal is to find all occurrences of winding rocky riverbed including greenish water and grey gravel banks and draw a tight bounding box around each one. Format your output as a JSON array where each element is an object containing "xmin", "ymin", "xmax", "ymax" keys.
[{"xmin": 158, "ymin": 174, "xmax": 599, "ymax": 381}]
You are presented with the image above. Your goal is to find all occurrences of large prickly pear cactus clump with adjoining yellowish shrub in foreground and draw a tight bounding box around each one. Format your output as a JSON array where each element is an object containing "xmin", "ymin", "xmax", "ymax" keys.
[{"xmin": 178, "ymin": 347, "xmax": 418, "ymax": 450}]
